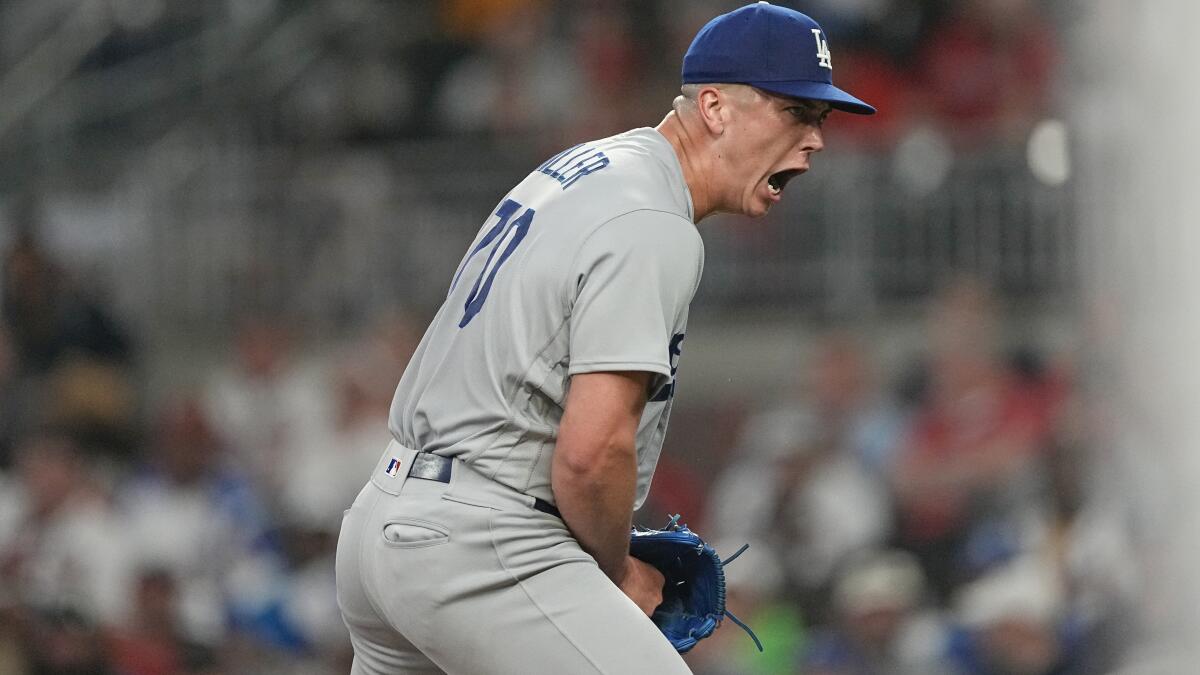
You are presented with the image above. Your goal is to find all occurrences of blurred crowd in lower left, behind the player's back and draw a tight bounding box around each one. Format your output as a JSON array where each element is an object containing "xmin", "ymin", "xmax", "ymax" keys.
[{"xmin": 0, "ymin": 218, "xmax": 419, "ymax": 675}]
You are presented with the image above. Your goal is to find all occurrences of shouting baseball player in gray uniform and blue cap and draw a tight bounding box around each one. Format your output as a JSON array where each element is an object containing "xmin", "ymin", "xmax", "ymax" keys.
[{"xmin": 337, "ymin": 2, "xmax": 874, "ymax": 674}]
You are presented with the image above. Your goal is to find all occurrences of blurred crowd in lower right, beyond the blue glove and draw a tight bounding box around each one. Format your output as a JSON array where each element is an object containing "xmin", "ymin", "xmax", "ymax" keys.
[{"xmin": 655, "ymin": 279, "xmax": 1152, "ymax": 675}]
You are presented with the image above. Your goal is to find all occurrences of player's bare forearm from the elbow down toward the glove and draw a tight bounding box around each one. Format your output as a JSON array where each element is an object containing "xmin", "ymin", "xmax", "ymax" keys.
[{"xmin": 551, "ymin": 447, "xmax": 637, "ymax": 585}]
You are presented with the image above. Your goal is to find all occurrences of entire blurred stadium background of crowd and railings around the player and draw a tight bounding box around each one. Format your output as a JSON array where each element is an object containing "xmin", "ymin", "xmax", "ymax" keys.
[{"xmin": 0, "ymin": 0, "xmax": 1185, "ymax": 675}]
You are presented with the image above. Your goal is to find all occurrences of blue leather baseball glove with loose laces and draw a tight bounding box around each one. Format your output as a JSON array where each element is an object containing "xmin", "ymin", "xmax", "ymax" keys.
[{"xmin": 629, "ymin": 515, "xmax": 762, "ymax": 653}]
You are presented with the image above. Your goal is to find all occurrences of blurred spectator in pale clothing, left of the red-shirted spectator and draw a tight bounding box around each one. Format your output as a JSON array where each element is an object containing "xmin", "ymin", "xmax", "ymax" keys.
[{"xmin": 707, "ymin": 330, "xmax": 905, "ymax": 622}]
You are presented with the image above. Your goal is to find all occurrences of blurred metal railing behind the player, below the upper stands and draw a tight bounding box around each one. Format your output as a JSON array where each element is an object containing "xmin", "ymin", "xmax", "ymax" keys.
[{"xmin": 88, "ymin": 133, "xmax": 1074, "ymax": 330}]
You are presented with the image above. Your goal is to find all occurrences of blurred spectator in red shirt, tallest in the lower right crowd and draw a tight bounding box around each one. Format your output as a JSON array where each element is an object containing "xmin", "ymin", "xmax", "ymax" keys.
[{"xmin": 892, "ymin": 280, "xmax": 1058, "ymax": 598}]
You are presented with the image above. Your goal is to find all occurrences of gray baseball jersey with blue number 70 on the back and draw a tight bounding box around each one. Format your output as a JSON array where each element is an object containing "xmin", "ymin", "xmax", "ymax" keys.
[{"xmin": 390, "ymin": 129, "xmax": 704, "ymax": 508}]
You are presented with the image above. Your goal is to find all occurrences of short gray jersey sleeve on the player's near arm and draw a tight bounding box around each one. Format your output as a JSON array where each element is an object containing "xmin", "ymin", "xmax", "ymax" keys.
[{"xmin": 568, "ymin": 210, "xmax": 703, "ymax": 388}]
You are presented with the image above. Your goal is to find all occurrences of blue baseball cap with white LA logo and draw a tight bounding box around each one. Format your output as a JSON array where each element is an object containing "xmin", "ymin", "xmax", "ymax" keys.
[{"xmin": 683, "ymin": 1, "xmax": 875, "ymax": 115}]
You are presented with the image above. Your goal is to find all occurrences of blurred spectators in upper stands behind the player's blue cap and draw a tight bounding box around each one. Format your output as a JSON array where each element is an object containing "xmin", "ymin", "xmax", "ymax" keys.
[{"xmin": 274, "ymin": 0, "xmax": 1060, "ymax": 151}]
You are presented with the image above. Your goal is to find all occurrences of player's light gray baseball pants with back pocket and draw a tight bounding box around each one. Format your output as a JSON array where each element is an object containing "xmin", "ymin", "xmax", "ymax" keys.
[{"xmin": 337, "ymin": 442, "xmax": 690, "ymax": 675}]
